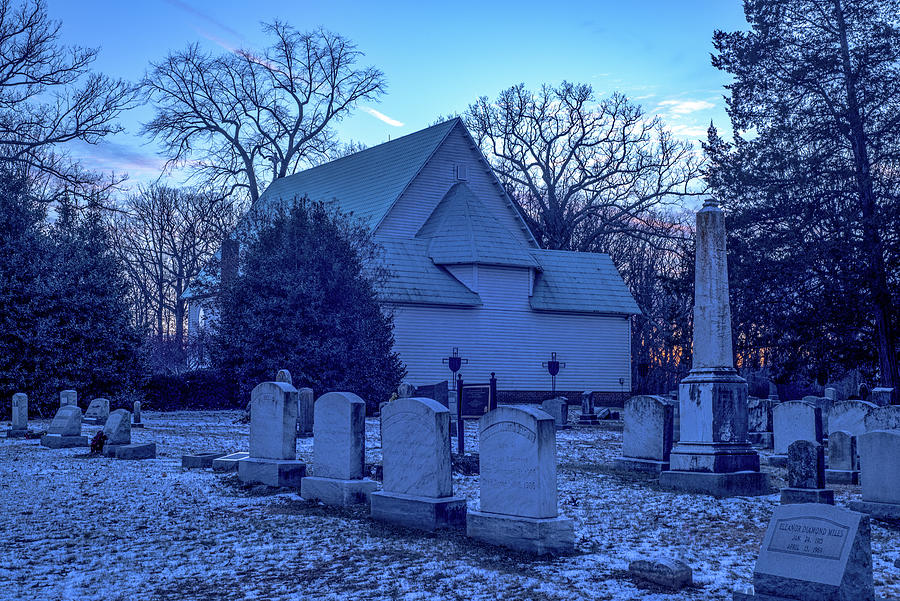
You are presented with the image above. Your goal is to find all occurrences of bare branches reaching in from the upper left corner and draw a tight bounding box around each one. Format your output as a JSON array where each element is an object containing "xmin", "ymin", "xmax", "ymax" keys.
[{"xmin": 0, "ymin": 0, "xmax": 137, "ymax": 187}]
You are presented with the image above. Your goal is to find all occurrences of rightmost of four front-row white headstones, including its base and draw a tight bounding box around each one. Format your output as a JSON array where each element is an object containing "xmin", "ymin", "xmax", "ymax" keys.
[{"xmin": 466, "ymin": 407, "xmax": 575, "ymax": 554}]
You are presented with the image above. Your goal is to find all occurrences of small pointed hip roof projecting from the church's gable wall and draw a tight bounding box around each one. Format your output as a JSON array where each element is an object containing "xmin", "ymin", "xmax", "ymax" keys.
[{"xmin": 416, "ymin": 182, "xmax": 540, "ymax": 268}]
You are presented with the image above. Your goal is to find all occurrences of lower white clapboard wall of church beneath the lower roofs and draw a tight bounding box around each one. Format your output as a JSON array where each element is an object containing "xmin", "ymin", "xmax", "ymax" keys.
[{"xmin": 392, "ymin": 266, "xmax": 631, "ymax": 392}]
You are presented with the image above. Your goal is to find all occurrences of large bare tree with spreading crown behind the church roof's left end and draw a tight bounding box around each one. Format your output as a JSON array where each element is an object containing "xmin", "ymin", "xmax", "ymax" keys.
[{"xmin": 143, "ymin": 21, "xmax": 385, "ymax": 203}]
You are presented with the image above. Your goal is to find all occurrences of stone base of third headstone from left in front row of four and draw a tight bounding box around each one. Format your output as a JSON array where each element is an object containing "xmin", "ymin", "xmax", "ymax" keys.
[{"xmin": 370, "ymin": 491, "xmax": 466, "ymax": 532}]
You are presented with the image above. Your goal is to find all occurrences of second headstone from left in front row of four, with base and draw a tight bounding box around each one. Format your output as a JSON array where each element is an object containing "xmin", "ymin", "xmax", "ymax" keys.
[{"xmin": 300, "ymin": 392, "xmax": 378, "ymax": 506}]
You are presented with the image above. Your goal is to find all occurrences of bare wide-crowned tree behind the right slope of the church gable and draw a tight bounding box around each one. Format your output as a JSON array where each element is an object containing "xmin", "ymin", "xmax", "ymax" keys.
[{"xmin": 464, "ymin": 82, "xmax": 703, "ymax": 251}]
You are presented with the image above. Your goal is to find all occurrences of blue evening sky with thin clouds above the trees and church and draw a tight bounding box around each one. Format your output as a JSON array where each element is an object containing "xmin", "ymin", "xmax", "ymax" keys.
[{"xmin": 47, "ymin": 0, "xmax": 746, "ymax": 181}]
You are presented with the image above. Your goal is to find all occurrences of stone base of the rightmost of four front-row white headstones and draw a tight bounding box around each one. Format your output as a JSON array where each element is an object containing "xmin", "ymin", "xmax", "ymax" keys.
[{"xmin": 466, "ymin": 511, "xmax": 575, "ymax": 555}]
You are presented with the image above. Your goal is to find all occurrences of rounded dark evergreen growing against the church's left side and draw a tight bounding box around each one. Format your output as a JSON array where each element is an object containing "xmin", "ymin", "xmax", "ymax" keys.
[{"xmin": 212, "ymin": 199, "xmax": 405, "ymax": 409}]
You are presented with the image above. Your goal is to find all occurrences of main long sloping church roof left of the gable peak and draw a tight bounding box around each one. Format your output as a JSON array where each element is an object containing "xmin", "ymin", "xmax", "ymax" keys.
[{"xmin": 258, "ymin": 118, "xmax": 459, "ymax": 228}]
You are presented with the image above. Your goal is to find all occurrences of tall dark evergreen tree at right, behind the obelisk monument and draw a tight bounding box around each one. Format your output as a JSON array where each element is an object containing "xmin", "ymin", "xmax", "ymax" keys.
[{"xmin": 706, "ymin": 0, "xmax": 900, "ymax": 402}]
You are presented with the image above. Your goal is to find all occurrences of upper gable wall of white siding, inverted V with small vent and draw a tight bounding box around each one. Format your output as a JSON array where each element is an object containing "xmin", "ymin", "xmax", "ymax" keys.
[{"xmin": 375, "ymin": 127, "xmax": 532, "ymax": 246}]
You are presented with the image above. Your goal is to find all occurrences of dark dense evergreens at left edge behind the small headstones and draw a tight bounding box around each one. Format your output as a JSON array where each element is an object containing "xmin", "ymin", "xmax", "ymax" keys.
[{"xmin": 0, "ymin": 166, "xmax": 141, "ymax": 416}]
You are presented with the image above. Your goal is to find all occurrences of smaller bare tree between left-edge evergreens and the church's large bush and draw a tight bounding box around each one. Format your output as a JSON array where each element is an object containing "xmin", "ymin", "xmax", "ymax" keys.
[{"xmin": 112, "ymin": 185, "xmax": 237, "ymax": 368}]
